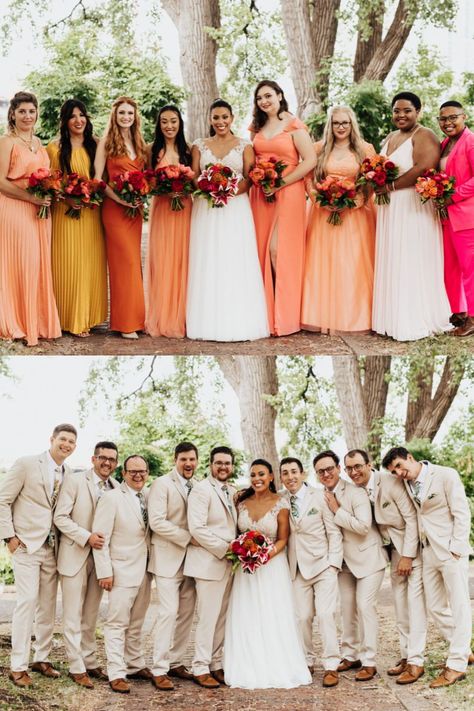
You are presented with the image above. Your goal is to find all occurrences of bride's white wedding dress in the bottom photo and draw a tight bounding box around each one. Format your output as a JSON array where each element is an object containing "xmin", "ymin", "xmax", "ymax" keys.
[{"xmin": 224, "ymin": 499, "xmax": 311, "ymax": 689}]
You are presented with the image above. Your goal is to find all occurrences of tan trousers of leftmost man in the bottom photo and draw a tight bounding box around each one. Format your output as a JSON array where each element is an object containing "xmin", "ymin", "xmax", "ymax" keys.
[{"xmin": 11, "ymin": 545, "xmax": 58, "ymax": 671}]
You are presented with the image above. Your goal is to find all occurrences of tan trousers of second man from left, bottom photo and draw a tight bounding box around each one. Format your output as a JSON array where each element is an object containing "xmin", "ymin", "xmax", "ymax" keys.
[{"xmin": 61, "ymin": 553, "xmax": 103, "ymax": 674}]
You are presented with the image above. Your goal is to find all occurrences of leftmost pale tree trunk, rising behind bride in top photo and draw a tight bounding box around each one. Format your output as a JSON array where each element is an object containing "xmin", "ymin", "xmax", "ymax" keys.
[{"xmin": 162, "ymin": 0, "xmax": 220, "ymax": 141}]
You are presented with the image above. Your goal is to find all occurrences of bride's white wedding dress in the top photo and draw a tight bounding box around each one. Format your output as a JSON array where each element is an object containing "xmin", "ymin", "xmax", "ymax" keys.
[{"xmin": 186, "ymin": 140, "xmax": 269, "ymax": 341}]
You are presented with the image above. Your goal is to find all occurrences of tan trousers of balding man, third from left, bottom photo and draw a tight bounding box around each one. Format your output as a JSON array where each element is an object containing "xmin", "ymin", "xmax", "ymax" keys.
[{"xmin": 104, "ymin": 573, "xmax": 150, "ymax": 681}]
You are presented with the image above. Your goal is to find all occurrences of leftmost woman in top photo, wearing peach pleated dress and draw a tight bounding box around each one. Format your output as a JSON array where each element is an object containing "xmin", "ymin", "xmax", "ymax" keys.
[{"xmin": 0, "ymin": 92, "xmax": 61, "ymax": 346}]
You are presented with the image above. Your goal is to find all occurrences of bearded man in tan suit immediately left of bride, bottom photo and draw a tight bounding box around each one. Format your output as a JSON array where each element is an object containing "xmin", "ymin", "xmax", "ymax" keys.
[{"xmin": 184, "ymin": 447, "xmax": 237, "ymax": 689}]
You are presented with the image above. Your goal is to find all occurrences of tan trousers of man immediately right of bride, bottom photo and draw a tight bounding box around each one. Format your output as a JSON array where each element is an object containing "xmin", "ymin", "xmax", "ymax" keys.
[{"xmin": 293, "ymin": 568, "xmax": 341, "ymax": 670}]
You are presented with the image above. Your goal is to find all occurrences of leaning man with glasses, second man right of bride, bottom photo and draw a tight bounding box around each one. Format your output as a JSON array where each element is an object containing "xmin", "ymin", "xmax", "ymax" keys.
[{"xmin": 313, "ymin": 450, "xmax": 388, "ymax": 681}]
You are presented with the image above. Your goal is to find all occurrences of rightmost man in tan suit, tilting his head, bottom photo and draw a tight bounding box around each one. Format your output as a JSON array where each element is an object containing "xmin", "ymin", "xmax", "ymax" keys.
[{"xmin": 382, "ymin": 447, "xmax": 474, "ymax": 689}]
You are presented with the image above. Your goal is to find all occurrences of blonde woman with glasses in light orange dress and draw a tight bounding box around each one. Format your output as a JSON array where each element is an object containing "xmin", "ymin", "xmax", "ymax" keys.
[{"xmin": 301, "ymin": 106, "xmax": 375, "ymax": 333}]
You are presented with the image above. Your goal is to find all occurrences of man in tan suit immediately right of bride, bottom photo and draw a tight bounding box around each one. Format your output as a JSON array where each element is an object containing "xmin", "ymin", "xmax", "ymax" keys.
[{"xmin": 280, "ymin": 457, "xmax": 342, "ymax": 687}]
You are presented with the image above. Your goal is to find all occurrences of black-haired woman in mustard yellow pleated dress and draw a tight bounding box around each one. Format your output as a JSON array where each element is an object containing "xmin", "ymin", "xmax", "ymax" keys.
[{"xmin": 46, "ymin": 99, "xmax": 107, "ymax": 337}]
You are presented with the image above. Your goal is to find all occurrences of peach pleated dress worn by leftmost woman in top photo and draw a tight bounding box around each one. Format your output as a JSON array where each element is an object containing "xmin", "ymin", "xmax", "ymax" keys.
[{"xmin": 0, "ymin": 143, "xmax": 61, "ymax": 346}]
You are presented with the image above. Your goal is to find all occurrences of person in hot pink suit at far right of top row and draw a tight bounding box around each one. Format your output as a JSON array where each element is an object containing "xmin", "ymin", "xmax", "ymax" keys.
[{"xmin": 438, "ymin": 101, "xmax": 474, "ymax": 336}]
